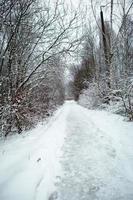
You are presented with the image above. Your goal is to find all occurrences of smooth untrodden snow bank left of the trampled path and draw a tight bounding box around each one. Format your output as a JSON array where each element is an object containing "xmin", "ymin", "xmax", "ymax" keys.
[{"xmin": 0, "ymin": 105, "xmax": 69, "ymax": 200}]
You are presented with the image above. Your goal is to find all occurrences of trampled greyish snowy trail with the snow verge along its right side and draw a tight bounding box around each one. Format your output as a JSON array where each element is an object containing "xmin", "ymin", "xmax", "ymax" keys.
[{"xmin": 55, "ymin": 104, "xmax": 133, "ymax": 200}]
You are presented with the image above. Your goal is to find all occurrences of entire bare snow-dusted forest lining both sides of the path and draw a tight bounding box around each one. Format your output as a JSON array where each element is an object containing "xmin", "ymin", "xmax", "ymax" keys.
[{"xmin": 0, "ymin": 0, "xmax": 133, "ymax": 136}]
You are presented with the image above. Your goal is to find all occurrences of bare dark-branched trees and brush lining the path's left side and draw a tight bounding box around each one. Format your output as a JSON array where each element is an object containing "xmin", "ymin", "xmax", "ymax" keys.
[{"xmin": 0, "ymin": 0, "xmax": 77, "ymax": 136}]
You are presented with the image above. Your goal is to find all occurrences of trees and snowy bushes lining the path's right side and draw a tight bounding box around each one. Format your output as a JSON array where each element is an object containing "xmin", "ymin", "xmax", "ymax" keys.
[{"xmin": 71, "ymin": 1, "xmax": 133, "ymax": 120}]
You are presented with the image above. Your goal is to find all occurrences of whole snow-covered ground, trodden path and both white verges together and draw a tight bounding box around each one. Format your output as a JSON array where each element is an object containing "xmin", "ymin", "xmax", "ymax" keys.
[{"xmin": 0, "ymin": 101, "xmax": 133, "ymax": 200}]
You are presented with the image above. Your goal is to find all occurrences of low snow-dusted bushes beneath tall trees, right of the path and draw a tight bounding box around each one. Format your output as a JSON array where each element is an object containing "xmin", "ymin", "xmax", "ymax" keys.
[{"xmin": 78, "ymin": 81, "xmax": 133, "ymax": 120}]
